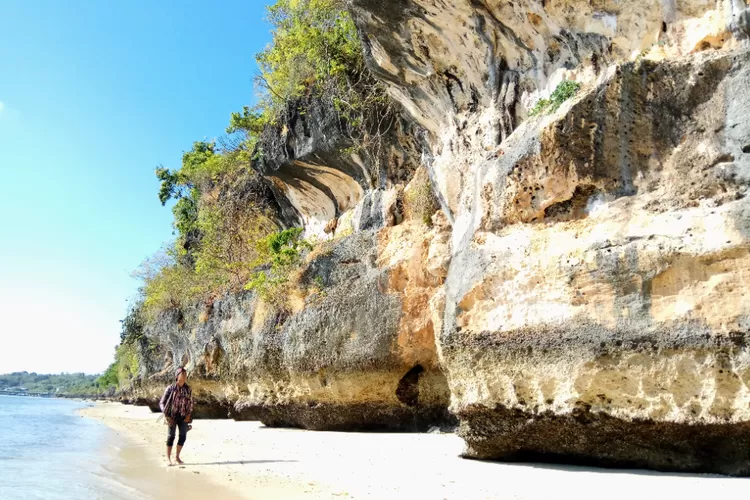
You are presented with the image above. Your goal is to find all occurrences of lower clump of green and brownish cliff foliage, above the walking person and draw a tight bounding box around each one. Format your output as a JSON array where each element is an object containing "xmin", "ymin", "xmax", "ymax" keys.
[{"xmin": 145, "ymin": 135, "xmax": 276, "ymax": 321}]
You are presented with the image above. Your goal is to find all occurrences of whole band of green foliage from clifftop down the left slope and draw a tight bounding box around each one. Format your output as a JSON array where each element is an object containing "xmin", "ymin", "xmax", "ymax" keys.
[{"xmin": 143, "ymin": 0, "xmax": 392, "ymax": 320}]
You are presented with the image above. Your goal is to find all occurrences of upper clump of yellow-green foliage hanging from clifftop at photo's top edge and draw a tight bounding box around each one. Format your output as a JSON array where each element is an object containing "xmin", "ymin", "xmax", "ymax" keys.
[{"xmin": 253, "ymin": 0, "xmax": 396, "ymax": 166}]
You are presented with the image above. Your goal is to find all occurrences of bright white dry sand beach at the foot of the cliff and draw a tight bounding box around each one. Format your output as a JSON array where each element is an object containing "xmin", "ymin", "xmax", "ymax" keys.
[{"xmin": 81, "ymin": 403, "xmax": 750, "ymax": 500}]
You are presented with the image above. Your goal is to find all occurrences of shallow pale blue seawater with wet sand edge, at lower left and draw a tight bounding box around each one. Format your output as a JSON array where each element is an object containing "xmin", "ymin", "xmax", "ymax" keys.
[{"xmin": 0, "ymin": 396, "xmax": 238, "ymax": 500}]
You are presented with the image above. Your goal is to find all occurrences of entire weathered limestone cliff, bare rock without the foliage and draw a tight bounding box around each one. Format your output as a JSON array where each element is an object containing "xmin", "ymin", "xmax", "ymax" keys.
[{"xmin": 129, "ymin": 0, "xmax": 750, "ymax": 475}]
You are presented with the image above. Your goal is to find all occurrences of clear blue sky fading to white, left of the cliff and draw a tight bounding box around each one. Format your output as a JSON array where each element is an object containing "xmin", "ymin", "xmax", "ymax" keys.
[{"xmin": 0, "ymin": 0, "xmax": 270, "ymax": 373}]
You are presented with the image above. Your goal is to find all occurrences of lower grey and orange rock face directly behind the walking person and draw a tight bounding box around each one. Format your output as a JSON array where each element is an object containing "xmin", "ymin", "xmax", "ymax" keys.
[{"xmin": 129, "ymin": 224, "xmax": 455, "ymax": 430}]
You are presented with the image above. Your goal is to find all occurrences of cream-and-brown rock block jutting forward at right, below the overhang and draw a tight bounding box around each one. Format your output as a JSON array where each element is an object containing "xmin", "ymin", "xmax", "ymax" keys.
[{"xmin": 442, "ymin": 52, "xmax": 750, "ymax": 474}]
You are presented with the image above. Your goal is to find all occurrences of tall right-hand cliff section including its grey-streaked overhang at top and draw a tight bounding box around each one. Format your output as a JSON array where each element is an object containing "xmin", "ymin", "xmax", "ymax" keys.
[{"xmin": 351, "ymin": 0, "xmax": 750, "ymax": 475}]
